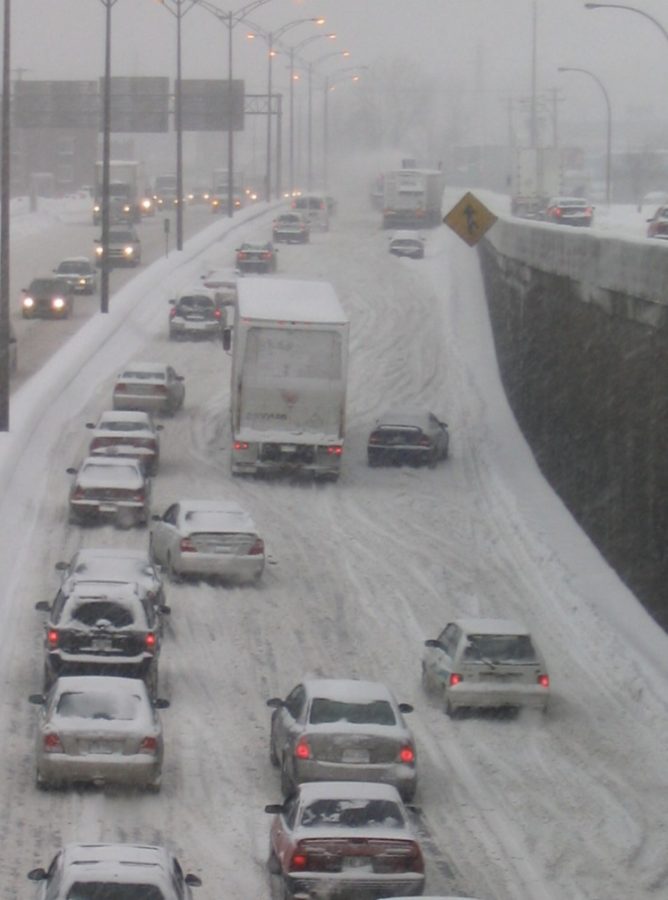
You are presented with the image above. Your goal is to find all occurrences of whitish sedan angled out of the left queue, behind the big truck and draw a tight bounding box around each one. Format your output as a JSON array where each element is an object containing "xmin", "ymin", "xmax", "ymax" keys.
[{"xmin": 150, "ymin": 500, "xmax": 265, "ymax": 581}]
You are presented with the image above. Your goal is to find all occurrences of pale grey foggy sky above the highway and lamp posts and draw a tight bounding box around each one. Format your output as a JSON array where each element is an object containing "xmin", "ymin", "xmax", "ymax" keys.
[{"xmin": 11, "ymin": 0, "xmax": 668, "ymax": 149}]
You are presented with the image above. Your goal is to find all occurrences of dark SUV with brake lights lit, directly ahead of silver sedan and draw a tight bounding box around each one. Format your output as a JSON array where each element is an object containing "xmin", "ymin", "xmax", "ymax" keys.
[{"xmin": 35, "ymin": 581, "xmax": 160, "ymax": 696}]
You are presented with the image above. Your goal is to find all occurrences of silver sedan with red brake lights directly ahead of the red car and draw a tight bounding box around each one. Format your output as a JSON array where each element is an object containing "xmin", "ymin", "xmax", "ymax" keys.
[{"xmin": 267, "ymin": 678, "xmax": 417, "ymax": 800}]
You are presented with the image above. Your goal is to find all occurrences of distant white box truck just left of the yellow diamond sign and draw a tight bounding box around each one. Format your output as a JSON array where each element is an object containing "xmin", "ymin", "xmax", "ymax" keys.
[{"xmin": 383, "ymin": 169, "xmax": 444, "ymax": 228}]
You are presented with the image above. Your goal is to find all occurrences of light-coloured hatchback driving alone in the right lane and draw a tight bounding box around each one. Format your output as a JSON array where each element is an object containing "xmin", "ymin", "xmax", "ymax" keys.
[{"xmin": 422, "ymin": 618, "xmax": 550, "ymax": 716}]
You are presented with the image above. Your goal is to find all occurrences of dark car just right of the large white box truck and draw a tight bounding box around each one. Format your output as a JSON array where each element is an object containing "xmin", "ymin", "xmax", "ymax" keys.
[{"xmin": 367, "ymin": 410, "xmax": 450, "ymax": 468}]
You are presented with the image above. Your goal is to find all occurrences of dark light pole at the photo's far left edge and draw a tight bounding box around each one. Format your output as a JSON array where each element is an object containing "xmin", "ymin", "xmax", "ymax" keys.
[{"xmin": 0, "ymin": 0, "xmax": 11, "ymax": 431}]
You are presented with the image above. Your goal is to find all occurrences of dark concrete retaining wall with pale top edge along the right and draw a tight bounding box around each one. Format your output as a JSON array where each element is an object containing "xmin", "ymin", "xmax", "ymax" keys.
[{"xmin": 479, "ymin": 219, "xmax": 668, "ymax": 628}]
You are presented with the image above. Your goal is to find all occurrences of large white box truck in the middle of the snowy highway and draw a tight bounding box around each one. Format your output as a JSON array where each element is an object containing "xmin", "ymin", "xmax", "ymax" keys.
[{"xmin": 224, "ymin": 277, "xmax": 348, "ymax": 481}]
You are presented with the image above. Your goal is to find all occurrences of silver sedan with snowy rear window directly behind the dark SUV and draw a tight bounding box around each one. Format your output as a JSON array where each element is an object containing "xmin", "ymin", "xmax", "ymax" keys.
[{"xmin": 30, "ymin": 675, "xmax": 169, "ymax": 791}]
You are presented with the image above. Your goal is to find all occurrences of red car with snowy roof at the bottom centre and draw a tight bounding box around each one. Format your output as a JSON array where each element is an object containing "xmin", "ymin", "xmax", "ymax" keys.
[{"xmin": 265, "ymin": 781, "xmax": 424, "ymax": 897}]
